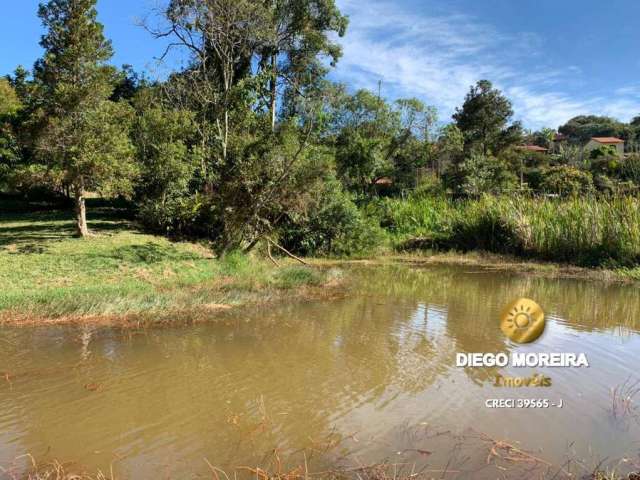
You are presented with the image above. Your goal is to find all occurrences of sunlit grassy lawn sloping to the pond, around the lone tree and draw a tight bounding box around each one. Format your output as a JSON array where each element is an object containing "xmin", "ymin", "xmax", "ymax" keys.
[{"xmin": 0, "ymin": 201, "xmax": 338, "ymax": 322}]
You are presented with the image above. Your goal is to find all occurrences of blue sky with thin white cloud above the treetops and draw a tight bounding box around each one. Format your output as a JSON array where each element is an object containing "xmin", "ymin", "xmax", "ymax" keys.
[{"xmin": 0, "ymin": 0, "xmax": 640, "ymax": 128}]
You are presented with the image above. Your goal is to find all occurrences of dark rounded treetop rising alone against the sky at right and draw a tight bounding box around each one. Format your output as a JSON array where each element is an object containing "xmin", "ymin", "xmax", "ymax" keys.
[{"xmin": 453, "ymin": 80, "xmax": 522, "ymax": 155}]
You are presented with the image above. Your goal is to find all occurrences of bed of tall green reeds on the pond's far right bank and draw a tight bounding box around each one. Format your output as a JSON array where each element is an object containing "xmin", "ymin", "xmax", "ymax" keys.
[{"xmin": 379, "ymin": 197, "xmax": 640, "ymax": 275}]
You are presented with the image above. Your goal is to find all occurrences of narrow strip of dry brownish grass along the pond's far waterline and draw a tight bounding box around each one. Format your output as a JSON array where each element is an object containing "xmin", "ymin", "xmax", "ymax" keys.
[{"xmin": 0, "ymin": 252, "xmax": 638, "ymax": 328}]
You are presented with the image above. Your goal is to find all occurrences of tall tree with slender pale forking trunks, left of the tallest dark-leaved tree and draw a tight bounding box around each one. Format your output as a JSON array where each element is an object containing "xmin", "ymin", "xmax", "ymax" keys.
[{"xmin": 147, "ymin": 0, "xmax": 269, "ymax": 184}]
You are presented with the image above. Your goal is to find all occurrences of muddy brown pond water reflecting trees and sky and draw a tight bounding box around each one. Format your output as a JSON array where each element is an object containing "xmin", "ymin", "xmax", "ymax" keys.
[{"xmin": 0, "ymin": 265, "xmax": 640, "ymax": 478}]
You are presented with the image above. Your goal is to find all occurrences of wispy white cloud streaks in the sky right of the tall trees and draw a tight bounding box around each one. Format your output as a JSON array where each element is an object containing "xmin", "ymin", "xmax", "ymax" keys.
[{"xmin": 335, "ymin": 0, "xmax": 640, "ymax": 128}]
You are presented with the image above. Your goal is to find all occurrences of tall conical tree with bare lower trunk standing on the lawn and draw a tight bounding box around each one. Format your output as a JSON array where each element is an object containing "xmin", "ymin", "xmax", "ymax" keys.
[{"xmin": 35, "ymin": 0, "xmax": 136, "ymax": 237}]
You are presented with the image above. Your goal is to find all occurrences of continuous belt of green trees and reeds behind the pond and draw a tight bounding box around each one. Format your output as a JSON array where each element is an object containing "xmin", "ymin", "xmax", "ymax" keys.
[{"xmin": 0, "ymin": 0, "xmax": 640, "ymax": 264}]
